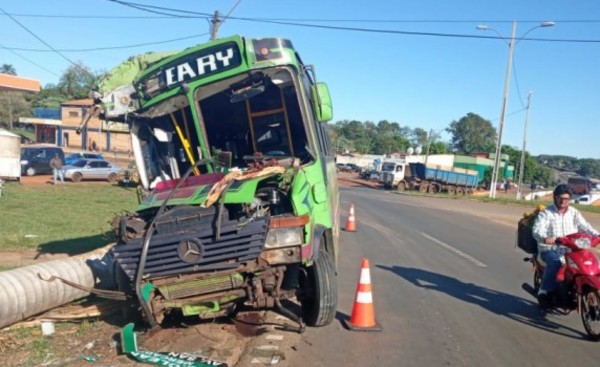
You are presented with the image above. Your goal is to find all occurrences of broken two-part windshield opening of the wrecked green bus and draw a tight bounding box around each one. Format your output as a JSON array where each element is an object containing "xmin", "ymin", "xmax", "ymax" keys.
[{"xmin": 132, "ymin": 68, "xmax": 313, "ymax": 187}]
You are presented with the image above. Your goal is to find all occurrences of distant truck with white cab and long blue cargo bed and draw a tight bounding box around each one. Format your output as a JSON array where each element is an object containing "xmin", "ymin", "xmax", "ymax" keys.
[{"xmin": 382, "ymin": 163, "xmax": 479, "ymax": 195}]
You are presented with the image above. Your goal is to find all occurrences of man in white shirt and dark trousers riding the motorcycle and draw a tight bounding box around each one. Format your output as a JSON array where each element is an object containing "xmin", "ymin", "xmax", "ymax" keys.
[{"xmin": 533, "ymin": 184, "xmax": 600, "ymax": 308}]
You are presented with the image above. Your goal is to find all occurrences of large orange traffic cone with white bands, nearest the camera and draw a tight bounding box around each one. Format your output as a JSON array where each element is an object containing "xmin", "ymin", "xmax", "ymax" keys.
[{"xmin": 344, "ymin": 259, "xmax": 381, "ymax": 331}]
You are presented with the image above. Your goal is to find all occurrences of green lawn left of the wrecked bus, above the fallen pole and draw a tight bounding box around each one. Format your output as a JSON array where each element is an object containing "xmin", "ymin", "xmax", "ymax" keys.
[{"xmin": 0, "ymin": 182, "xmax": 137, "ymax": 254}]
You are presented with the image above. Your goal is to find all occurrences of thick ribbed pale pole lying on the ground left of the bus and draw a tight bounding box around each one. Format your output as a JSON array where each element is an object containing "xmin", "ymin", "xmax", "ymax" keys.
[{"xmin": 0, "ymin": 246, "xmax": 114, "ymax": 328}]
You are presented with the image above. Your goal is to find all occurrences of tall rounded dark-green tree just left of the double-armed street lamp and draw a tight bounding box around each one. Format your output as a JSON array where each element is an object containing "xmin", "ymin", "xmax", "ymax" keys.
[{"xmin": 446, "ymin": 112, "xmax": 497, "ymax": 154}]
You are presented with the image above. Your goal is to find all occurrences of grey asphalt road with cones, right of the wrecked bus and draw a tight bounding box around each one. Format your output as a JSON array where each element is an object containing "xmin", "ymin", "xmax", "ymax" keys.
[{"xmin": 276, "ymin": 188, "xmax": 600, "ymax": 366}]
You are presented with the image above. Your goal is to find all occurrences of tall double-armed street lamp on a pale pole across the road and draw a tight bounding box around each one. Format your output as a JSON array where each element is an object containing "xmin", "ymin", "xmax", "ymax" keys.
[{"xmin": 477, "ymin": 21, "xmax": 554, "ymax": 198}]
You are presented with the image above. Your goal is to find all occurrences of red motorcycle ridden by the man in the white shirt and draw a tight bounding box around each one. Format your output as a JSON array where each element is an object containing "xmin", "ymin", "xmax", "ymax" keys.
[{"xmin": 524, "ymin": 233, "xmax": 600, "ymax": 341}]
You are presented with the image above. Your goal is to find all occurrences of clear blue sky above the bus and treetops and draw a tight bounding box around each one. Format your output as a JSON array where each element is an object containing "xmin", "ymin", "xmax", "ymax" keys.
[{"xmin": 0, "ymin": 0, "xmax": 600, "ymax": 159}]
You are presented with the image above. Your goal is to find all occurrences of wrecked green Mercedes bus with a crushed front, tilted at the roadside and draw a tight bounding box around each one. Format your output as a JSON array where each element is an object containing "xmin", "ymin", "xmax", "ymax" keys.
[{"xmin": 94, "ymin": 36, "xmax": 339, "ymax": 327}]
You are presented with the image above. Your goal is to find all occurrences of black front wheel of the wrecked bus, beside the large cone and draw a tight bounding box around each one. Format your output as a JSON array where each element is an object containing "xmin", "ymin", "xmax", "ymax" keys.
[{"xmin": 300, "ymin": 250, "xmax": 337, "ymax": 326}]
